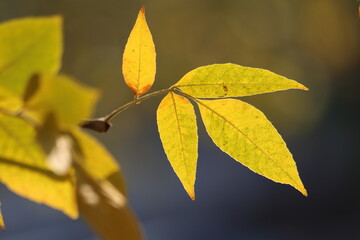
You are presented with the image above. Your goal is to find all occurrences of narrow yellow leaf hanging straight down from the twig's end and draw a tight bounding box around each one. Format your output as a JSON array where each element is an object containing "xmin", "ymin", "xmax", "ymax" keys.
[{"xmin": 157, "ymin": 93, "xmax": 198, "ymax": 200}]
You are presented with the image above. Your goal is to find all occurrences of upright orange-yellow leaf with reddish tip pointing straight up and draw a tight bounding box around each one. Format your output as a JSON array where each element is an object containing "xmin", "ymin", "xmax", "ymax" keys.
[{"xmin": 122, "ymin": 7, "xmax": 156, "ymax": 96}]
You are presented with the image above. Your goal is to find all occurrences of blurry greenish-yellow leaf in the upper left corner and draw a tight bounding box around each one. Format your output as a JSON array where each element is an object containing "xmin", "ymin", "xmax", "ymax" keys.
[{"xmin": 0, "ymin": 16, "xmax": 62, "ymax": 96}]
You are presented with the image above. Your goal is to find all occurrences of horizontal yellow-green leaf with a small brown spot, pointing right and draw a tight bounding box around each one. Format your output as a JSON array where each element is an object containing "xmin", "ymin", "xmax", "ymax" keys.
[{"xmin": 174, "ymin": 63, "xmax": 308, "ymax": 98}]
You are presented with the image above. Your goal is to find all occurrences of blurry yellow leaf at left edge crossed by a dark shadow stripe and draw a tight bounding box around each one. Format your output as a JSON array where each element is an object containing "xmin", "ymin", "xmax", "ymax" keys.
[{"xmin": 0, "ymin": 114, "xmax": 78, "ymax": 218}]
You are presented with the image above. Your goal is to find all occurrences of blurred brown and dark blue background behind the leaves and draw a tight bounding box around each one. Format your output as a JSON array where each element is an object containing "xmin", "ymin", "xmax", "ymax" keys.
[{"xmin": 0, "ymin": 0, "xmax": 360, "ymax": 240}]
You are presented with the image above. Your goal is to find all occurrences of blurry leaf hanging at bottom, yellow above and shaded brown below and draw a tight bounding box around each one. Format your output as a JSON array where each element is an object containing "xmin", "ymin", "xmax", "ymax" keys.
[{"xmin": 72, "ymin": 126, "xmax": 142, "ymax": 240}]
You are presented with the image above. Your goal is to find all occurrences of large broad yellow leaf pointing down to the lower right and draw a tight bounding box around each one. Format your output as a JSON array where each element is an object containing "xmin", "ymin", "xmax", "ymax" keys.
[{"xmin": 196, "ymin": 99, "xmax": 307, "ymax": 196}]
